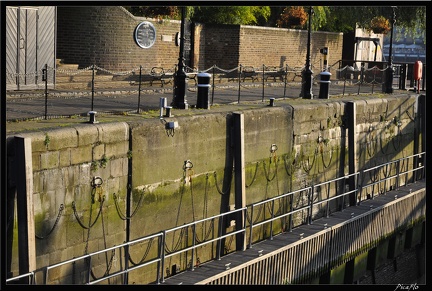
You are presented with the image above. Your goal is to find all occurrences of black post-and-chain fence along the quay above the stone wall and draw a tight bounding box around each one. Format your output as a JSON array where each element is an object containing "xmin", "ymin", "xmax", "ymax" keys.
[{"xmin": 6, "ymin": 60, "xmax": 426, "ymax": 121}]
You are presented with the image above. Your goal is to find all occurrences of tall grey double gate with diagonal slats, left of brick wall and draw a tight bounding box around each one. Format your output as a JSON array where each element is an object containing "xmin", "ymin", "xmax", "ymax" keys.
[{"xmin": 6, "ymin": 6, "xmax": 56, "ymax": 90}]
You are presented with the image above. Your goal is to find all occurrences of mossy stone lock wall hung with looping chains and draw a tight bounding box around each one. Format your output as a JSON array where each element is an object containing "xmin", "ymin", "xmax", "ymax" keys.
[{"xmin": 7, "ymin": 96, "xmax": 416, "ymax": 284}]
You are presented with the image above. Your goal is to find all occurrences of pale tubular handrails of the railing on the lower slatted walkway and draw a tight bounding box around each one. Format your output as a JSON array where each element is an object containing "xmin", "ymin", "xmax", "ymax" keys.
[{"xmin": 6, "ymin": 152, "xmax": 426, "ymax": 284}]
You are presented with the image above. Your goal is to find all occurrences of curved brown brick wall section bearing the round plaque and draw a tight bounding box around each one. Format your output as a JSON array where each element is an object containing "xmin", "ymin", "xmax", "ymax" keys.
[{"xmin": 57, "ymin": 6, "xmax": 180, "ymax": 71}]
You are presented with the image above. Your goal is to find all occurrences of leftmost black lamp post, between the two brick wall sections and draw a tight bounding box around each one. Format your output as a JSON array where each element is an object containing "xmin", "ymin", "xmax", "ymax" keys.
[{"xmin": 171, "ymin": 6, "xmax": 189, "ymax": 109}]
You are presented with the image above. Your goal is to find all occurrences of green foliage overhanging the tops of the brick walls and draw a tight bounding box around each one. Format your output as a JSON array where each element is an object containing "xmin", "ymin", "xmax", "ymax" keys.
[{"xmin": 125, "ymin": 6, "xmax": 426, "ymax": 40}]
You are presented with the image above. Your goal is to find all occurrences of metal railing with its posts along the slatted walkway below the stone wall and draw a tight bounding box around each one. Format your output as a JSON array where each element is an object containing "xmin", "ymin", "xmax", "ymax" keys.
[{"xmin": 6, "ymin": 152, "xmax": 426, "ymax": 285}]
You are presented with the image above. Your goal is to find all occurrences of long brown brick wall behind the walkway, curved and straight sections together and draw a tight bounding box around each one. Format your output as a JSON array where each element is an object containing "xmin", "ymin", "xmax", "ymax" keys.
[{"xmin": 57, "ymin": 6, "xmax": 343, "ymax": 72}]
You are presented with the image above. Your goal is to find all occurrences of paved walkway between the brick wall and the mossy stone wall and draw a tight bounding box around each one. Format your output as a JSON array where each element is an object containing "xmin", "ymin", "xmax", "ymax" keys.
[{"xmin": 6, "ymin": 82, "xmax": 416, "ymax": 121}]
